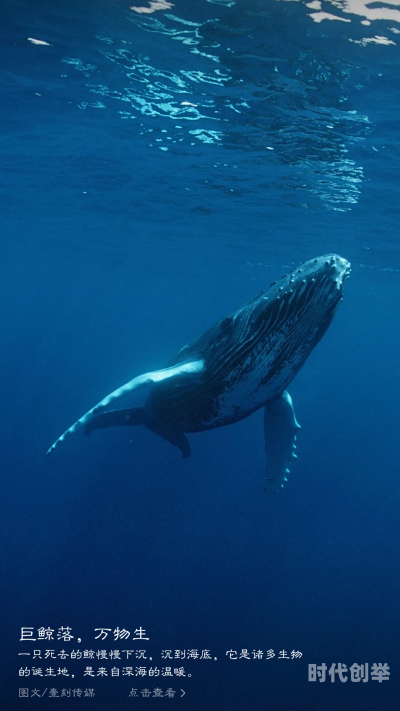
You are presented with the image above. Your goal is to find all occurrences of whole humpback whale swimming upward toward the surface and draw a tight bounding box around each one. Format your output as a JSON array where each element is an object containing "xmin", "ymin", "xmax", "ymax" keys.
[{"xmin": 48, "ymin": 254, "xmax": 350, "ymax": 492}]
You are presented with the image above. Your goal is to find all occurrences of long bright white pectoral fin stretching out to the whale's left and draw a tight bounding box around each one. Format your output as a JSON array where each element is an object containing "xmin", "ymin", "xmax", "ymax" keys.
[{"xmin": 47, "ymin": 360, "xmax": 205, "ymax": 454}]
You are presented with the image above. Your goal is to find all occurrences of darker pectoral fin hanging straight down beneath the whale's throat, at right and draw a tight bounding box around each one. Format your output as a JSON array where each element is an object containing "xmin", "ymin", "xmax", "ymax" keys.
[{"xmin": 264, "ymin": 390, "xmax": 300, "ymax": 492}]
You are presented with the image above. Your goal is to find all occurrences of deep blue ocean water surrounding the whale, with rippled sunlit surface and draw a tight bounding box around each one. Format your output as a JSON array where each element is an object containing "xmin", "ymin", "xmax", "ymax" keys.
[{"xmin": 0, "ymin": 0, "xmax": 400, "ymax": 711}]
